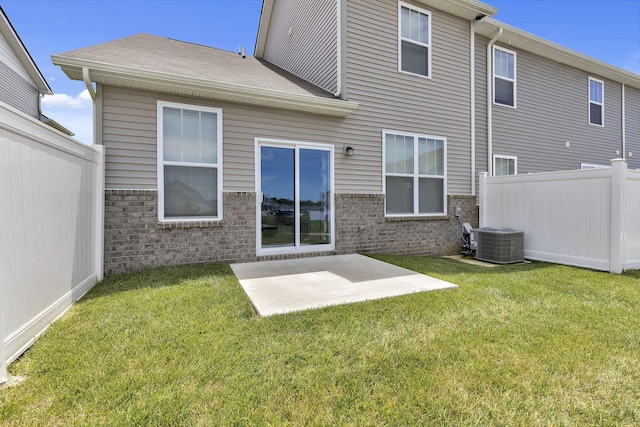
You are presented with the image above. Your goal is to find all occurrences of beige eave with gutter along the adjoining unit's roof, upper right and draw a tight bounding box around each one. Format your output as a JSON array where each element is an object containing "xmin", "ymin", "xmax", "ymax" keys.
[{"xmin": 476, "ymin": 17, "xmax": 640, "ymax": 89}]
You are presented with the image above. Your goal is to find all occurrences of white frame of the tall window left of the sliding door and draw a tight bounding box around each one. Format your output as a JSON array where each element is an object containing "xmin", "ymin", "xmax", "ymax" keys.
[{"xmin": 156, "ymin": 101, "xmax": 223, "ymax": 223}]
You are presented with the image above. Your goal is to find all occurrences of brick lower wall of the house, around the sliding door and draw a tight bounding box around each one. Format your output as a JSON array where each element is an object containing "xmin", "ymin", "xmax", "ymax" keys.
[{"xmin": 104, "ymin": 190, "xmax": 478, "ymax": 274}]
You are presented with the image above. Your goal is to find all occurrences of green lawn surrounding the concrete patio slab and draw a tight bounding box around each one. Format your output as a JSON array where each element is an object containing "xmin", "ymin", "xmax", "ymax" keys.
[{"xmin": 0, "ymin": 256, "xmax": 640, "ymax": 426}]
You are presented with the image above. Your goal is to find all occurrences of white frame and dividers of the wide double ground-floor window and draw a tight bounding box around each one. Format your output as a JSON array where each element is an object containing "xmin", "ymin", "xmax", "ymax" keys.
[{"xmin": 382, "ymin": 129, "xmax": 447, "ymax": 217}]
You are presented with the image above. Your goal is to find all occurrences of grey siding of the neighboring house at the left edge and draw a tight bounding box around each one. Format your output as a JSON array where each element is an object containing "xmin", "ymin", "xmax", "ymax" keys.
[{"xmin": 0, "ymin": 62, "xmax": 40, "ymax": 119}]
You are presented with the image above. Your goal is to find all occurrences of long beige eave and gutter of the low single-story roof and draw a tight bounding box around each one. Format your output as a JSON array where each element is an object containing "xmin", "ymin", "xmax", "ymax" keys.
[{"xmin": 51, "ymin": 55, "xmax": 358, "ymax": 117}]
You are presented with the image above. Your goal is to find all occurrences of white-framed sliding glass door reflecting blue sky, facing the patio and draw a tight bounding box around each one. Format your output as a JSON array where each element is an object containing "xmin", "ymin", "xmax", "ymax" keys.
[{"xmin": 257, "ymin": 143, "xmax": 333, "ymax": 253}]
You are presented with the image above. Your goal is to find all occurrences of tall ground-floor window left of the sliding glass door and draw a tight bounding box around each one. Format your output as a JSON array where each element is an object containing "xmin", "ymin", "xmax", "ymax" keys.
[{"xmin": 158, "ymin": 102, "xmax": 222, "ymax": 221}]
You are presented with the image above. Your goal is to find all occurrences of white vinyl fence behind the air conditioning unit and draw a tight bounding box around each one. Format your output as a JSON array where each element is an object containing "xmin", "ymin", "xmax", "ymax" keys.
[{"xmin": 480, "ymin": 159, "xmax": 640, "ymax": 273}]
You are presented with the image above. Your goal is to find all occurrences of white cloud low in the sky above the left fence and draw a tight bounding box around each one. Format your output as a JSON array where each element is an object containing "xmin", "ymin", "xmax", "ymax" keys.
[{"xmin": 42, "ymin": 89, "xmax": 93, "ymax": 145}]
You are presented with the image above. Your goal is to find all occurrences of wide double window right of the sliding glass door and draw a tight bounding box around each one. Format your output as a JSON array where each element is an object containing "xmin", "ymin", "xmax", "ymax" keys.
[{"xmin": 382, "ymin": 131, "xmax": 447, "ymax": 215}]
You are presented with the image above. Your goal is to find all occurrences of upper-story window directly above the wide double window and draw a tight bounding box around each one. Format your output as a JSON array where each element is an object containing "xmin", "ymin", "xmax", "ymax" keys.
[{"xmin": 398, "ymin": 3, "xmax": 431, "ymax": 77}]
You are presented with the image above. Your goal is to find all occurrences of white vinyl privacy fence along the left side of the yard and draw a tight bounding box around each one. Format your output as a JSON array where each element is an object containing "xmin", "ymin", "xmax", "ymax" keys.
[{"xmin": 0, "ymin": 103, "xmax": 104, "ymax": 382}]
